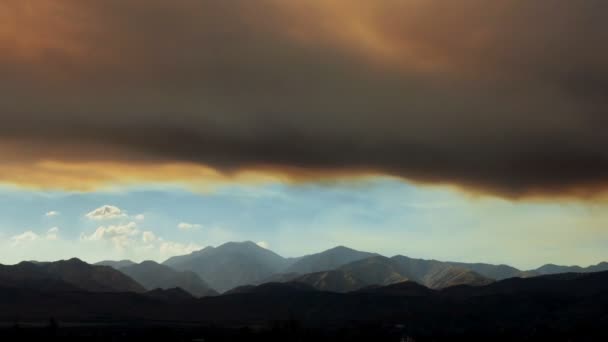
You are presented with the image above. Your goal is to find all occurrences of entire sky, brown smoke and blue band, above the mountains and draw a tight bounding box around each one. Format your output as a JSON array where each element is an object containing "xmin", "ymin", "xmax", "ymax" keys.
[{"xmin": 0, "ymin": 0, "xmax": 608, "ymax": 268}]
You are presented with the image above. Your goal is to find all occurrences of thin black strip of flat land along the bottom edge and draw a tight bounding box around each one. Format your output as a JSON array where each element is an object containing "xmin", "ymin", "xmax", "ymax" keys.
[{"xmin": 0, "ymin": 321, "xmax": 608, "ymax": 342}]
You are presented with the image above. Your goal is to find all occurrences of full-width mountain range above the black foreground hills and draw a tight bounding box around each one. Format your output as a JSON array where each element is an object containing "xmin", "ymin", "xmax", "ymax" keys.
[{"xmin": 0, "ymin": 241, "xmax": 608, "ymax": 297}]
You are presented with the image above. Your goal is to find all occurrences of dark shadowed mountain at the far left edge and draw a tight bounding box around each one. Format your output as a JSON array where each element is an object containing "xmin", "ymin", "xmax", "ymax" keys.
[{"xmin": 0, "ymin": 259, "xmax": 145, "ymax": 292}]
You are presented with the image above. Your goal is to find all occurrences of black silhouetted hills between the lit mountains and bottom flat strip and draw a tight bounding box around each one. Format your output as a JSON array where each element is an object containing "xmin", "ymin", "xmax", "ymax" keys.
[{"xmin": 0, "ymin": 272, "xmax": 608, "ymax": 341}]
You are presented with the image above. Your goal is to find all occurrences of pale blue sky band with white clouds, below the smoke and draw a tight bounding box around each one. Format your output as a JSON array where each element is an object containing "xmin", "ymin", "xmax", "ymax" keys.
[{"xmin": 0, "ymin": 178, "xmax": 608, "ymax": 268}]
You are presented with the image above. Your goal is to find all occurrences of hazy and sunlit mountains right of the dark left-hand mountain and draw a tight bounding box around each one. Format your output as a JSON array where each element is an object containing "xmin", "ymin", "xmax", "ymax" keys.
[{"xmin": 108, "ymin": 241, "xmax": 608, "ymax": 297}]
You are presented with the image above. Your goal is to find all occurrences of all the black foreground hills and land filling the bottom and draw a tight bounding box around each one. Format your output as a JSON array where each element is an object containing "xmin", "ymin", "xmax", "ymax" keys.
[{"xmin": 0, "ymin": 272, "xmax": 608, "ymax": 341}]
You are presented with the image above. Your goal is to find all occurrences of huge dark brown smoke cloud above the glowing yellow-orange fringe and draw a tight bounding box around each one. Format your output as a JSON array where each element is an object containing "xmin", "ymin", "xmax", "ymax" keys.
[{"xmin": 0, "ymin": 0, "xmax": 608, "ymax": 197}]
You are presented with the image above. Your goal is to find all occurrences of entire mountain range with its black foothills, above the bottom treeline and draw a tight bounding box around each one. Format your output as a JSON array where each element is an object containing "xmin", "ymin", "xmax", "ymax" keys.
[{"xmin": 0, "ymin": 242, "xmax": 608, "ymax": 341}]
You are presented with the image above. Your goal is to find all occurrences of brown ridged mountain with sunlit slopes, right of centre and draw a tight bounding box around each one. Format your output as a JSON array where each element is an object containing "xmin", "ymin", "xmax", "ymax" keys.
[{"xmin": 292, "ymin": 256, "xmax": 492, "ymax": 292}]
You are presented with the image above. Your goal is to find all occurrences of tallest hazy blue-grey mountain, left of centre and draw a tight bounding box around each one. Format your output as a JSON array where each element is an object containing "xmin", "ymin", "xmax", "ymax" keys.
[{"xmin": 163, "ymin": 241, "xmax": 288, "ymax": 292}]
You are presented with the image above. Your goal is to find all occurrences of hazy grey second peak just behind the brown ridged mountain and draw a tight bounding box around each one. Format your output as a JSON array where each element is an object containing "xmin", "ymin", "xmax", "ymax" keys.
[{"xmin": 284, "ymin": 246, "xmax": 378, "ymax": 274}]
